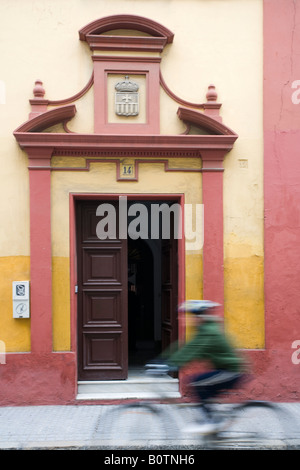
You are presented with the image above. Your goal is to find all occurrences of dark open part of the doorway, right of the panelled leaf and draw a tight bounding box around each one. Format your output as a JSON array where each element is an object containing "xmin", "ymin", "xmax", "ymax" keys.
[{"xmin": 127, "ymin": 200, "xmax": 178, "ymax": 370}]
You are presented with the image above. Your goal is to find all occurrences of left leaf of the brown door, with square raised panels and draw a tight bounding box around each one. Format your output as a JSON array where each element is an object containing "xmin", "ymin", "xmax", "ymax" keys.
[{"xmin": 76, "ymin": 201, "xmax": 128, "ymax": 380}]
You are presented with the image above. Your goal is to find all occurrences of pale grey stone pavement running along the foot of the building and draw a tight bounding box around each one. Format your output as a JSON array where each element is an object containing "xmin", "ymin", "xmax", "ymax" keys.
[{"xmin": 0, "ymin": 403, "xmax": 300, "ymax": 451}]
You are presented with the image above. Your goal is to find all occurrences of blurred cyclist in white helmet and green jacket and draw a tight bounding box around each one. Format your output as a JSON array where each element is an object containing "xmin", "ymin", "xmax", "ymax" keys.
[{"xmin": 163, "ymin": 300, "xmax": 244, "ymax": 433}]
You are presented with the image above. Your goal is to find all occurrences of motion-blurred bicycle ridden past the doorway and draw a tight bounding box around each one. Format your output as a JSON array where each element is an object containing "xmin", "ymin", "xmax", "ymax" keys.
[{"xmin": 96, "ymin": 363, "xmax": 291, "ymax": 449}]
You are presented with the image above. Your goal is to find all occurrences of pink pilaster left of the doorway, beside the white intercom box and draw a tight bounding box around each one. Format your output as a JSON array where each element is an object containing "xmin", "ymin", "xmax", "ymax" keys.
[{"xmin": 27, "ymin": 147, "xmax": 52, "ymax": 353}]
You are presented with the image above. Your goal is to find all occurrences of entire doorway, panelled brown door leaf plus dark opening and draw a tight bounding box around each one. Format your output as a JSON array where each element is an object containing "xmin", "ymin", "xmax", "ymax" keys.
[{"xmin": 76, "ymin": 197, "xmax": 179, "ymax": 381}]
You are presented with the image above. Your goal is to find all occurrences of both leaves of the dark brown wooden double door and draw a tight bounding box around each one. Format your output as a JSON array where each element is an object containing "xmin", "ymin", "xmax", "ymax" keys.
[{"xmin": 76, "ymin": 200, "xmax": 178, "ymax": 381}]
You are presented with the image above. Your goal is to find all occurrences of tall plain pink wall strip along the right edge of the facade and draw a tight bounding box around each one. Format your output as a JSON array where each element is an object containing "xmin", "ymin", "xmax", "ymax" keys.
[{"xmin": 262, "ymin": 0, "xmax": 300, "ymax": 401}]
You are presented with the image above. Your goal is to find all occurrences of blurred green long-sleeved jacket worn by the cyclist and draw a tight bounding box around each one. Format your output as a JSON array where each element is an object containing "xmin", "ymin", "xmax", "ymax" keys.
[{"xmin": 167, "ymin": 317, "xmax": 243, "ymax": 372}]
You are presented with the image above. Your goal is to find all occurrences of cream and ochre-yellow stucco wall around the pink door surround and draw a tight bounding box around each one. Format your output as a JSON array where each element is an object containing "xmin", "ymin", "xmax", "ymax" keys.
[{"xmin": 0, "ymin": 0, "xmax": 264, "ymax": 351}]
